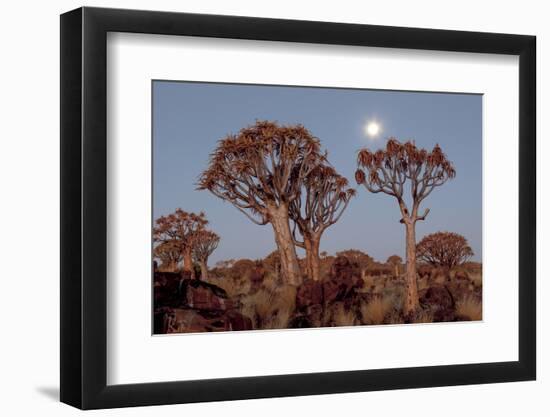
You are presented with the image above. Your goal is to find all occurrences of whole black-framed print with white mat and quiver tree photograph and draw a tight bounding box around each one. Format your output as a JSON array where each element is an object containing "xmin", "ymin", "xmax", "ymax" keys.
[{"xmin": 61, "ymin": 8, "xmax": 536, "ymax": 409}]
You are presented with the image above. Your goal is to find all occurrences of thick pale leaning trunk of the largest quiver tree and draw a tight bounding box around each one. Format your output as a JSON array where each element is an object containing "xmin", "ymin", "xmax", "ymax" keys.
[{"xmin": 269, "ymin": 204, "xmax": 302, "ymax": 286}]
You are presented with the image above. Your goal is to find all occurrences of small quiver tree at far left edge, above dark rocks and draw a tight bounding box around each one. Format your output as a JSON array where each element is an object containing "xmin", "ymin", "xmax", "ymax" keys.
[{"xmin": 153, "ymin": 208, "xmax": 208, "ymax": 278}]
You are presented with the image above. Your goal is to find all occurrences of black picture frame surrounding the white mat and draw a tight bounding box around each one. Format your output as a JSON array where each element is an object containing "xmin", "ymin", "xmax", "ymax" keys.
[{"xmin": 60, "ymin": 7, "xmax": 536, "ymax": 409}]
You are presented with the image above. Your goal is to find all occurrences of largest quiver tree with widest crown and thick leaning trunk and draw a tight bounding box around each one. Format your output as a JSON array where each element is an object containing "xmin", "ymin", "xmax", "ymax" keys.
[{"xmin": 198, "ymin": 121, "xmax": 323, "ymax": 285}]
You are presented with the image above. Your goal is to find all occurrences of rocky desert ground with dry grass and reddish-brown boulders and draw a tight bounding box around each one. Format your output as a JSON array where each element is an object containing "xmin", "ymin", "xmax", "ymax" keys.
[{"xmin": 154, "ymin": 250, "xmax": 482, "ymax": 334}]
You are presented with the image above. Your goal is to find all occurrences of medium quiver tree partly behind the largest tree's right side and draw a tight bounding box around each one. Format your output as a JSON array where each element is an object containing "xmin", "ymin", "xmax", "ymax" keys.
[{"xmin": 289, "ymin": 164, "xmax": 355, "ymax": 281}]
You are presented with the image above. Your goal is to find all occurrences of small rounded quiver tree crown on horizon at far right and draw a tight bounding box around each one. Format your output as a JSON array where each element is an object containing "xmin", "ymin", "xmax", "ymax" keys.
[{"xmin": 416, "ymin": 232, "xmax": 474, "ymax": 270}]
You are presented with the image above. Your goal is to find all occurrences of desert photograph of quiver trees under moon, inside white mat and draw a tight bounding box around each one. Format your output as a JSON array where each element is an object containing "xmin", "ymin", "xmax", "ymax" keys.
[{"xmin": 151, "ymin": 80, "xmax": 483, "ymax": 334}]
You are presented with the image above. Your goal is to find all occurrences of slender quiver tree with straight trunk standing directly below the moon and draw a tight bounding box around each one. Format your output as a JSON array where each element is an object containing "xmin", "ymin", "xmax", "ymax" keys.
[{"xmin": 355, "ymin": 138, "xmax": 456, "ymax": 314}]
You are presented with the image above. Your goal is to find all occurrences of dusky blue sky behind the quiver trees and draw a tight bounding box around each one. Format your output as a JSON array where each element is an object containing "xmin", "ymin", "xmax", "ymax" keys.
[{"xmin": 153, "ymin": 81, "xmax": 482, "ymax": 264}]
